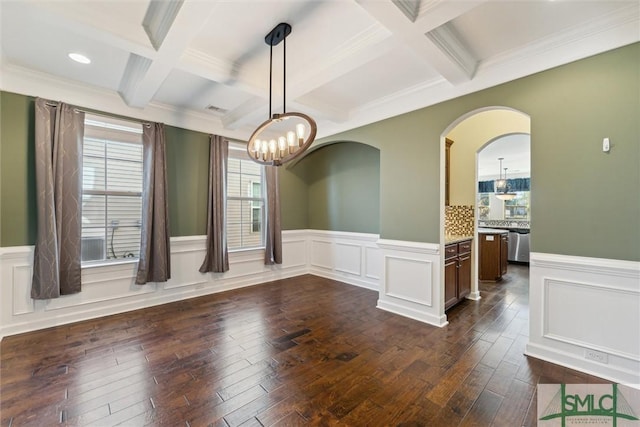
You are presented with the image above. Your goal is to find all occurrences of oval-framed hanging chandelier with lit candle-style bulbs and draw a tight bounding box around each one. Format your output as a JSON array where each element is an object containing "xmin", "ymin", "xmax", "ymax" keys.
[{"xmin": 247, "ymin": 23, "xmax": 318, "ymax": 166}]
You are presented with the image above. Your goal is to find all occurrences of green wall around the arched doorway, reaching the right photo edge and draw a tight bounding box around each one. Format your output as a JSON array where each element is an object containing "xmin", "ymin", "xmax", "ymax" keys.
[{"xmin": 292, "ymin": 43, "xmax": 640, "ymax": 261}]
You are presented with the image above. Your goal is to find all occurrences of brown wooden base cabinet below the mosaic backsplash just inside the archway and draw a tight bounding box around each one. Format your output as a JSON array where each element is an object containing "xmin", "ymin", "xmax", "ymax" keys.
[{"xmin": 444, "ymin": 240, "xmax": 471, "ymax": 310}]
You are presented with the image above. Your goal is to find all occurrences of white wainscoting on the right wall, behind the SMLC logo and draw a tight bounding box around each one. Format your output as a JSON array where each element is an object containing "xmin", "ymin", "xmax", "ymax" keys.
[{"xmin": 526, "ymin": 253, "xmax": 640, "ymax": 387}]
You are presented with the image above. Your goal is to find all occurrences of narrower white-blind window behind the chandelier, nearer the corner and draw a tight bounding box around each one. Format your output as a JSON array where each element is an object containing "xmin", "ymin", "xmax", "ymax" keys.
[{"xmin": 227, "ymin": 143, "xmax": 265, "ymax": 250}]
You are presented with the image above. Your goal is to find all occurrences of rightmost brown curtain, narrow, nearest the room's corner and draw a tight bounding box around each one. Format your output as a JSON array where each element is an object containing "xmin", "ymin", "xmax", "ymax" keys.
[{"xmin": 264, "ymin": 166, "xmax": 282, "ymax": 265}]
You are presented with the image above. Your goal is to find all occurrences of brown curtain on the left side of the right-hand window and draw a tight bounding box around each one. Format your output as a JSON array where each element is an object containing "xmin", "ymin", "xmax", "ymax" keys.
[{"xmin": 200, "ymin": 135, "xmax": 229, "ymax": 273}]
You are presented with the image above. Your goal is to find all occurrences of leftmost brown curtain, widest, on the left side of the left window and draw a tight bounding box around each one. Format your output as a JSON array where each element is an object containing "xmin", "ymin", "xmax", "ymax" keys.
[{"xmin": 31, "ymin": 98, "xmax": 84, "ymax": 299}]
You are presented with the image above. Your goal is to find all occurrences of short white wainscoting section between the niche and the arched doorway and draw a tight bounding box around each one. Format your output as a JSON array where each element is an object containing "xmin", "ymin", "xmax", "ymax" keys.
[{"xmin": 378, "ymin": 240, "xmax": 447, "ymax": 326}]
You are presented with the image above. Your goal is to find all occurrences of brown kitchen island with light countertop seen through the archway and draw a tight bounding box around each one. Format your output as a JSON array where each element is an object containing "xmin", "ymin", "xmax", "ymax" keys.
[{"xmin": 478, "ymin": 229, "xmax": 509, "ymax": 282}]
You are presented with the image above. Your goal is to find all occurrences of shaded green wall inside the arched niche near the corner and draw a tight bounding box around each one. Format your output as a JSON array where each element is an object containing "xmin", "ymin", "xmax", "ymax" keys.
[{"xmin": 283, "ymin": 142, "xmax": 380, "ymax": 234}]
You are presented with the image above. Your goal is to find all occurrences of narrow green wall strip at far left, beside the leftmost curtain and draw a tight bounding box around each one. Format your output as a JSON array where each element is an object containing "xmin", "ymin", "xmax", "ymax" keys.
[{"xmin": 0, "ymin": 92, "xmax": 36, "ymax": 247}]
